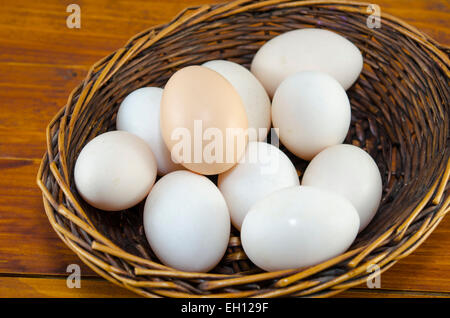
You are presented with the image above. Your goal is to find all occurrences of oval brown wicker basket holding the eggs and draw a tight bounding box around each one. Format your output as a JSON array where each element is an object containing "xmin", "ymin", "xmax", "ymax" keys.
[{"xmin": 37, "ymin": 0, "xmax": 450, "ymax": 297}]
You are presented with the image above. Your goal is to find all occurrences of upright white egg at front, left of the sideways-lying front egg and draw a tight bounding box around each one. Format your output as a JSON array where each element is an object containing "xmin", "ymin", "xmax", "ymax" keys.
[{"xmin": 144, "ymin": 171, "xmax": 230, "ymax": 272}]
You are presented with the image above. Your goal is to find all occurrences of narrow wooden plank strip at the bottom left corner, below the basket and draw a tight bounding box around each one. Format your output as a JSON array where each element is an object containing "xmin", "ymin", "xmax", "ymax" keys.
[{"xmin": 0, "ymin": 276, "xmax": 139, "ymax": 298}]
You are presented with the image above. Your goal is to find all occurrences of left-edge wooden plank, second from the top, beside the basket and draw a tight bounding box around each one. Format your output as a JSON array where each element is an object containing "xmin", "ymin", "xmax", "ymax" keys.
[{"xmin": 0, "ymin": 63, "xmax": 87, "ymax": 159}]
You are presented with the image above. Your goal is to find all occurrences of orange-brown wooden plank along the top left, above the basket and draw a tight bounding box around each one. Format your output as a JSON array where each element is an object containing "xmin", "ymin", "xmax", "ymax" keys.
[{"xmin": 0, "ymin": 0, "xmax": 214, "ymax": 65}]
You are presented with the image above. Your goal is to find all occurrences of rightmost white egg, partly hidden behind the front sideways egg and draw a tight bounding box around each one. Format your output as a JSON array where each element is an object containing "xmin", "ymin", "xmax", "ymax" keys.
[{"xmin": 302, "ymin": 145, "xmax": 383, "ymax": 231}]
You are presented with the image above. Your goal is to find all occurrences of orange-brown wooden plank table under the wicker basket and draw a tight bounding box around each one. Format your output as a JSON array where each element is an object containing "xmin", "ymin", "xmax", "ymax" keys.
[{"xmin": 0, "ymin": 0, "xmax": 450, "ymax": 297}]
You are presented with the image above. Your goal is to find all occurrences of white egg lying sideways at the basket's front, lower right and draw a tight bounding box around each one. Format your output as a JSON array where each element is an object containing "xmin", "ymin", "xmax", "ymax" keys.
[{"xmin": 241, "ymin": 186, "xmax": 359, "ymax": 271}]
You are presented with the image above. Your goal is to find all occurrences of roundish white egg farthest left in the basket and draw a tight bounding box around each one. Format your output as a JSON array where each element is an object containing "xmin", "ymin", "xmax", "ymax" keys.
[{"xmin": 74, "ymin": 131, "xmax": 156, "ymax": 211}]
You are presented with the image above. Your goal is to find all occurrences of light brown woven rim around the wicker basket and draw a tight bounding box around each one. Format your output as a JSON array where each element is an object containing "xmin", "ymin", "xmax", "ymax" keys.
[{"xmin": 37, "ymin": 0, "xmax": 450, "ymax": 297}]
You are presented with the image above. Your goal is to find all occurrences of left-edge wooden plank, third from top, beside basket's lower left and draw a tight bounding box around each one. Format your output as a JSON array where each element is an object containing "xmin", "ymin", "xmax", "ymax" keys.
[{"xmin": 0, "ymin": 159, "xmax": 94, "ymax": 274}]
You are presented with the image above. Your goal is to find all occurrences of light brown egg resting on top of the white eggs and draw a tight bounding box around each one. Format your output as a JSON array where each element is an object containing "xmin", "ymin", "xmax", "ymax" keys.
[{"xmin": 160, "ymin": 66, "xmax": 248, "ymax": 175}]
